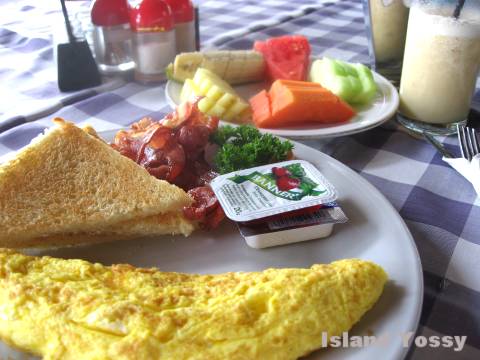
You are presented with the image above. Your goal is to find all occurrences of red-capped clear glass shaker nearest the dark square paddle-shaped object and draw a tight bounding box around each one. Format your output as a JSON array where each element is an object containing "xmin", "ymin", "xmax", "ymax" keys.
[{"xmin": 90, "ymin": 0, "xmax": 135, "ymax": 74}]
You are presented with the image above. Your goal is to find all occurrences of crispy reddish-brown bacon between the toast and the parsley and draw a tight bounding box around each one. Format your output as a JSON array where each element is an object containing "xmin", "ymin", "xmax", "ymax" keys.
[{"xmin": 111, "ymin": 98, "xmax": 225, "ymax": 229}]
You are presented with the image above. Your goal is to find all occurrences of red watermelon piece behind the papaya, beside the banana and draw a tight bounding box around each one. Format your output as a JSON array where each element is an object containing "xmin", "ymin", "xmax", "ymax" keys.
[{"xmin": 253, "ymin": 35, "xmax": 310, "ymax": 81}]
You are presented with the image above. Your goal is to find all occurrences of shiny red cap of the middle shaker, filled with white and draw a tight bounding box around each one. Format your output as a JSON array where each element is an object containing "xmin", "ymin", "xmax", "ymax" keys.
[{"xmin": 130, "ymin": 0, "xmax": 174, "ymax": 32}]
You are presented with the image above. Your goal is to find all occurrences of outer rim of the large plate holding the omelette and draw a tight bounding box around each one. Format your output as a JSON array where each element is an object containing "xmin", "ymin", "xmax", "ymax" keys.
[{"xmin": 0, "ymin": 130, "xmax": 424, "ymax": 360}]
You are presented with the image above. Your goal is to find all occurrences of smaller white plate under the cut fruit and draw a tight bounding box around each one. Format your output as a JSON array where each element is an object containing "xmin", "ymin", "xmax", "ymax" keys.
[{"xmin": 165, "ymin": 72, "xmax": 399, "ymax": 139}]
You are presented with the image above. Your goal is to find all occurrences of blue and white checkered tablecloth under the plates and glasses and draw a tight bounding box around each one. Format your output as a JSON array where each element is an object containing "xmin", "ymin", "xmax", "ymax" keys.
[{"xmin": 0, "ymin": 0, "xmax": 480, "ymax": 359}]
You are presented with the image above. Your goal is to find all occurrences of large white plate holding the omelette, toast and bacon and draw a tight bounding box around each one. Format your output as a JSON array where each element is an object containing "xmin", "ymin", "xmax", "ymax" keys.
[{"xmin": 0, "ymin": 132, "xmax": 423, "ymax": 360}]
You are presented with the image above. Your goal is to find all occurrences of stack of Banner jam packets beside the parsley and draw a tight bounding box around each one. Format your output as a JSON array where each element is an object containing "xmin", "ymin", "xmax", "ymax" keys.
[{"xmin": 210, "ymin": 160, "xmax": 348, "ymax": 249}]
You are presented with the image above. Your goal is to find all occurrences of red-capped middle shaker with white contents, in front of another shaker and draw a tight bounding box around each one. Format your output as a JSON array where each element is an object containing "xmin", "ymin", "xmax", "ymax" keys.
[{"xmin": 130, "ymin": 0, "xmax": 176, "ymax": 83}]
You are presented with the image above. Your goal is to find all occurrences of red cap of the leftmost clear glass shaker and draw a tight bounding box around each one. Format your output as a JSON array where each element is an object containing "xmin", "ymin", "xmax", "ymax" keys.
[{"xmin": 90, "ymin": 0, "xmax": 129, "ymax": 26}]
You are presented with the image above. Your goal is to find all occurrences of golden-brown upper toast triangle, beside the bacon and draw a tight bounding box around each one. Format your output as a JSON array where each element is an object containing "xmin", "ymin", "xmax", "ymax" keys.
[{"xmin": 0, "ymin": 118, "xmax": 192, "ymax": 247}]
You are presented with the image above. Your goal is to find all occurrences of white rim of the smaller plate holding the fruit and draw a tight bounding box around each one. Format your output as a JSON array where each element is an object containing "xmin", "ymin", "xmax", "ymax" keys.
[{"xmin": 165, "ymin": 70, "xmax": 400, "ymax": 140}]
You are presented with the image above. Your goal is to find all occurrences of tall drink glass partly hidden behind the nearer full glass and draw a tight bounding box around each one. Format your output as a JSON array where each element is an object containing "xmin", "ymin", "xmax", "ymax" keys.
[{"xmin": 363, "ymin": 0, "xmax": 409, "ymax": 84}]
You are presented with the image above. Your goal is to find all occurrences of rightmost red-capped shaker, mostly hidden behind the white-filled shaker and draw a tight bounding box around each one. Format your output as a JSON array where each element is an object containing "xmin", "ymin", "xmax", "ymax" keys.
[{"xmin": 166, "ymin": 0, "xmax": 196, "ymax": 53}]
